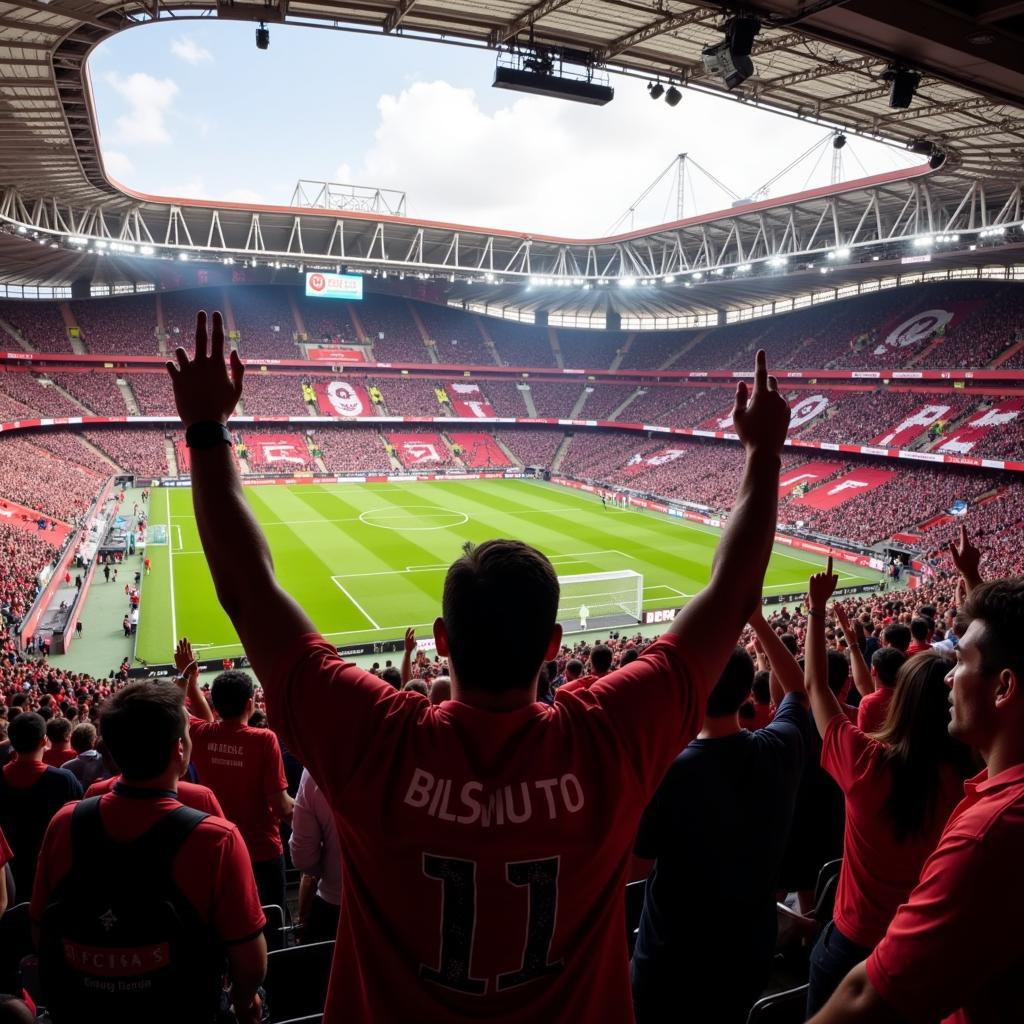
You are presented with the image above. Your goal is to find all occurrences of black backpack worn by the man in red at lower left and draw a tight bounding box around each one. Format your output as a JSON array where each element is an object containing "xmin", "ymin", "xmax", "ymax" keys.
[{"xmin": 39, "ymin": 797, "xmax": 224, "ymax": 1024}]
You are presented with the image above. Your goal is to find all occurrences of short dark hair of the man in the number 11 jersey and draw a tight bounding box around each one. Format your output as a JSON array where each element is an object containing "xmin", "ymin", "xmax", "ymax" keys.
[{"xmin": 441, "ymin": 540, "xmax": 559, "ymax": 693}]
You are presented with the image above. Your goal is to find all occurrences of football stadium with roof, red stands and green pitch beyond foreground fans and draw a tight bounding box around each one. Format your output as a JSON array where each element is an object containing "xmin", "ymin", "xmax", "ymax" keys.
[{"xmin": 0, "ymin": 0, "xmax": 1024, "ymax": 1024}]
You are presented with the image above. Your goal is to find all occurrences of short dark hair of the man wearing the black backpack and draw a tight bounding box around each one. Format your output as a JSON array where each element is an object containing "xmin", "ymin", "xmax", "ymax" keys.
[{"xmin": 99, "ymin": 679, "xmax": 188, "ymax": 781}]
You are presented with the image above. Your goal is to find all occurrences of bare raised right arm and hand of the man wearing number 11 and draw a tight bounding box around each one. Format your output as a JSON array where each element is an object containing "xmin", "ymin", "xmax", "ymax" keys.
[{"xmin": 669, "ymin": 351, "xmax": 790, "ymax": 681}]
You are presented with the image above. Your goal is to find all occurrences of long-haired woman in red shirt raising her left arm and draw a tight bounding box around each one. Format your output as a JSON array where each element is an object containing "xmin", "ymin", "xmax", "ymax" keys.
[{"xmin": 806, "ymin": 558, "xmax": 972, "ymax": 1017}]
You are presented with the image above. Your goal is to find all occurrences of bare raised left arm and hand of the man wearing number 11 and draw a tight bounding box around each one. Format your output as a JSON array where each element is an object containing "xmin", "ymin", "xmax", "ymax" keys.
[{"xmin": 167, "ymin": 312, "xmax": 315, "ymax": 686}]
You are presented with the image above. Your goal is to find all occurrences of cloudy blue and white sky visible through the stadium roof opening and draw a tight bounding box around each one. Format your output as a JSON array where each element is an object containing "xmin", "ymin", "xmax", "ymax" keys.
[{"xmin": 90, "ymin": 19, "xmax": 916, "ymax": 237}]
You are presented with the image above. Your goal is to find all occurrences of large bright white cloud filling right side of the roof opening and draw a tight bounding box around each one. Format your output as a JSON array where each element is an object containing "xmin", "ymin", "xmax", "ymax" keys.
[{"xmin": 337, "ymin": 79, "xmax": 921, "ymax": 237}]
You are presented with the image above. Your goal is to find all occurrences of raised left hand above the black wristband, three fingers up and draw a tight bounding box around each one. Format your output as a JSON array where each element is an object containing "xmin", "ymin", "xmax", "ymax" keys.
[{"xmin": 167, "ymin": 310, "xmax": 245, "ymax": 427}]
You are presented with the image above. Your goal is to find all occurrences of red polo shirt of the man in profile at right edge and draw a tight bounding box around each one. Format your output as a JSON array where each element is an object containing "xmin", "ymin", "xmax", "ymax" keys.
[{"xmin": 867, "ymin": 764, "xmax": 1024, "ymax": 1024}]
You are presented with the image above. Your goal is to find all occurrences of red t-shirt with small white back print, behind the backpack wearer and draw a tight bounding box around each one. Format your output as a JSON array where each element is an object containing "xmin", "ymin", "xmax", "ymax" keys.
[{"xmin": 188, "ymin": 718, "xmax": 288, "ymax": 862}]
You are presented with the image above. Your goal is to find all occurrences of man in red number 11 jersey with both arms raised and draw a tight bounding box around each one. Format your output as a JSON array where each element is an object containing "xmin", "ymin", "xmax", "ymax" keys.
[{"xmin": 168, "ymin": 313, "xmax": 790, "ymax": 1024}]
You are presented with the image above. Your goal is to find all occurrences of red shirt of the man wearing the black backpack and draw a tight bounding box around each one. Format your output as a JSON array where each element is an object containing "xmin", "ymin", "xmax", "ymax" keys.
[{"xmin": 31, "ymin": 793, "xmax": 266, "ymax": 945}]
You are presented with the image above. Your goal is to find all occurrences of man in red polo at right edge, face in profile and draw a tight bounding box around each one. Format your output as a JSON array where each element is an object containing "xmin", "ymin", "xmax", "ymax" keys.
[{"xmin": 813, "ymin": 577, "xmax": 1024, "ymax": 1024}]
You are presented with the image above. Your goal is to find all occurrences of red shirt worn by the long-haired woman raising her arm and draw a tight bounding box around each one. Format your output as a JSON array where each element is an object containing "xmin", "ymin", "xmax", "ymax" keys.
[{"xmin": 821, "ymin": 715, "xmax": 964, "ymax": 947}]
